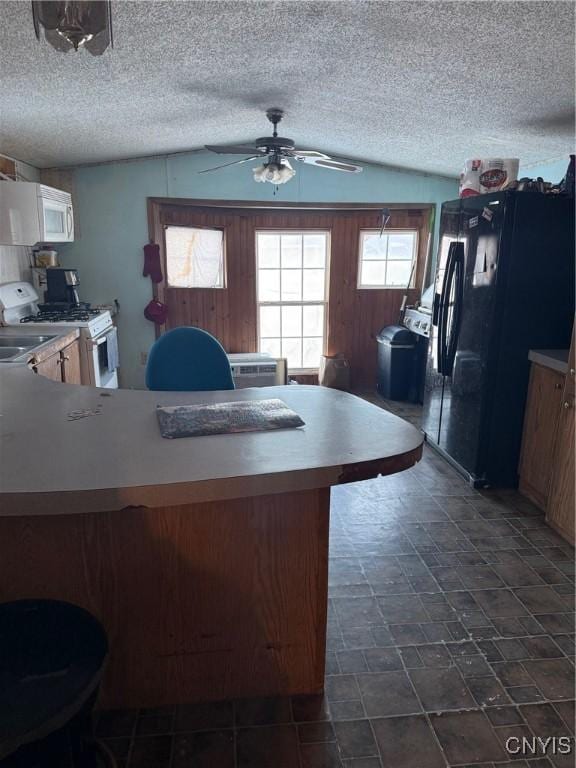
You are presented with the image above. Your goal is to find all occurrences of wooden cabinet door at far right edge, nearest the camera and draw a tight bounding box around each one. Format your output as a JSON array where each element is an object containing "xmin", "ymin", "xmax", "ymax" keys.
[{"xmin": 546, "ymin": 393, "xmax": 576, "ymax": 544}]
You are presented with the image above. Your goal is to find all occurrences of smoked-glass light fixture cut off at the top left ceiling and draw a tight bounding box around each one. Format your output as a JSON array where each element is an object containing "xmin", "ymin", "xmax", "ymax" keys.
[{"xmin": 32, "ymin": 0, "xmax": 113, "ymax": 56}]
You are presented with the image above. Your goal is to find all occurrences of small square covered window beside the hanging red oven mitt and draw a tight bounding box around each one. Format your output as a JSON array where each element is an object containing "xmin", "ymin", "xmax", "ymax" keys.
[{"xmin": 166, "ymin": 227, "xmax": 226, "ymax": 288}]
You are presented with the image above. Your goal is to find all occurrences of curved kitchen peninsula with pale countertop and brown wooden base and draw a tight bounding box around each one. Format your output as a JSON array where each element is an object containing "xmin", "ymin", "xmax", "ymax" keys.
[{"xmin": 0, "ymin": 365, "xmax": 422, "ymax": 707}]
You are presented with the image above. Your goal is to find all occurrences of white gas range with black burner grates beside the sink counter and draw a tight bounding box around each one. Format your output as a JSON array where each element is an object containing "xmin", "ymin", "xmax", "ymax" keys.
[{"xmin": 0, "ymin": 282, "xmax": 118, "ymax": 389}]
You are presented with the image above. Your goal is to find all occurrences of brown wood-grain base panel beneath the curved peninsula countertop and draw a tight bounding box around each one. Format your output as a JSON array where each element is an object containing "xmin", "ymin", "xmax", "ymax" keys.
[{"xmin": 0, "ymin": 488, "xmax": 330, "ymax": 707}]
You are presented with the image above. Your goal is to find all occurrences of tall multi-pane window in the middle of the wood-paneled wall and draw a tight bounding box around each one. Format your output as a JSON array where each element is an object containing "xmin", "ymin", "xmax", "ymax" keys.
[{"xmin": 256, "ymin": 231, "xmax": 329, "ymax": 370}]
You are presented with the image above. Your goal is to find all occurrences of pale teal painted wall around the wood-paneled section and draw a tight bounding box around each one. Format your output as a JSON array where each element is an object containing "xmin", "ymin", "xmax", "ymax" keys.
[{"xmin": 59, "ymin": 151, "xmax": 458, "ymax": 388}]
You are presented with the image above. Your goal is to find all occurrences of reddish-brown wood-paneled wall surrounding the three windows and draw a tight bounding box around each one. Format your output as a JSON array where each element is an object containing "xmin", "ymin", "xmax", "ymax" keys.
[{"xmin": 149, "ymin": 199, "xmax": 430, "ymax": 387}]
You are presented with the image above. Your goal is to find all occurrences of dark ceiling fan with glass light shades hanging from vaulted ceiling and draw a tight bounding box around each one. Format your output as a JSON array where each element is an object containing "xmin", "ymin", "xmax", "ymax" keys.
[{"xmin": 199, "ymin": 107, "xmax": 362, "ymax": 184}]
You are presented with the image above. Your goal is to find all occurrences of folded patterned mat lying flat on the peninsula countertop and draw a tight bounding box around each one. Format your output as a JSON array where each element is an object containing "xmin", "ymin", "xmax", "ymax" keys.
[{"xmin": 156, "ymin": 399, "xmax": 304, "ymax": 438}]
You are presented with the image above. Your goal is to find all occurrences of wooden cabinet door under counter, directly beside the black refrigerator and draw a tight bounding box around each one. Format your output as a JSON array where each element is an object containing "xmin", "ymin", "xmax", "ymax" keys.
[{"xmin": 519, "ymin": 363, "xmax": 564, "ymax": 509}]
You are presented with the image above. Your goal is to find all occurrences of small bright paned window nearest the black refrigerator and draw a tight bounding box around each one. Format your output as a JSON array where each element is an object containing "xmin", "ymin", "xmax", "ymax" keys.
[{"xmin": 358, "ymin": 229, "xmax": 418, "ymax": 288}]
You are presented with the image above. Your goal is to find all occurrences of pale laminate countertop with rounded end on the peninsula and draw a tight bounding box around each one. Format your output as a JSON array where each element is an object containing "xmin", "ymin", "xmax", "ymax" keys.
[{"xmin": 0, "ymin": 364, "xmax": 423, "ymax": 515}]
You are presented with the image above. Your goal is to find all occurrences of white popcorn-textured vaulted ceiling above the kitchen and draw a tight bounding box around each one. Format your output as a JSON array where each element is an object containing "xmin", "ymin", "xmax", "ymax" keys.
[{"xmin": 0, "ymin": 0, "xmax": 574, "ymax": 175}]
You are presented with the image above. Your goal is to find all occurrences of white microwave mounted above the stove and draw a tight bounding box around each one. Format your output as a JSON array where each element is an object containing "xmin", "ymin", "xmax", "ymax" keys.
[{"xmin": 0, "ymin": 181, "xmax": 74, "ymax": 245}]
